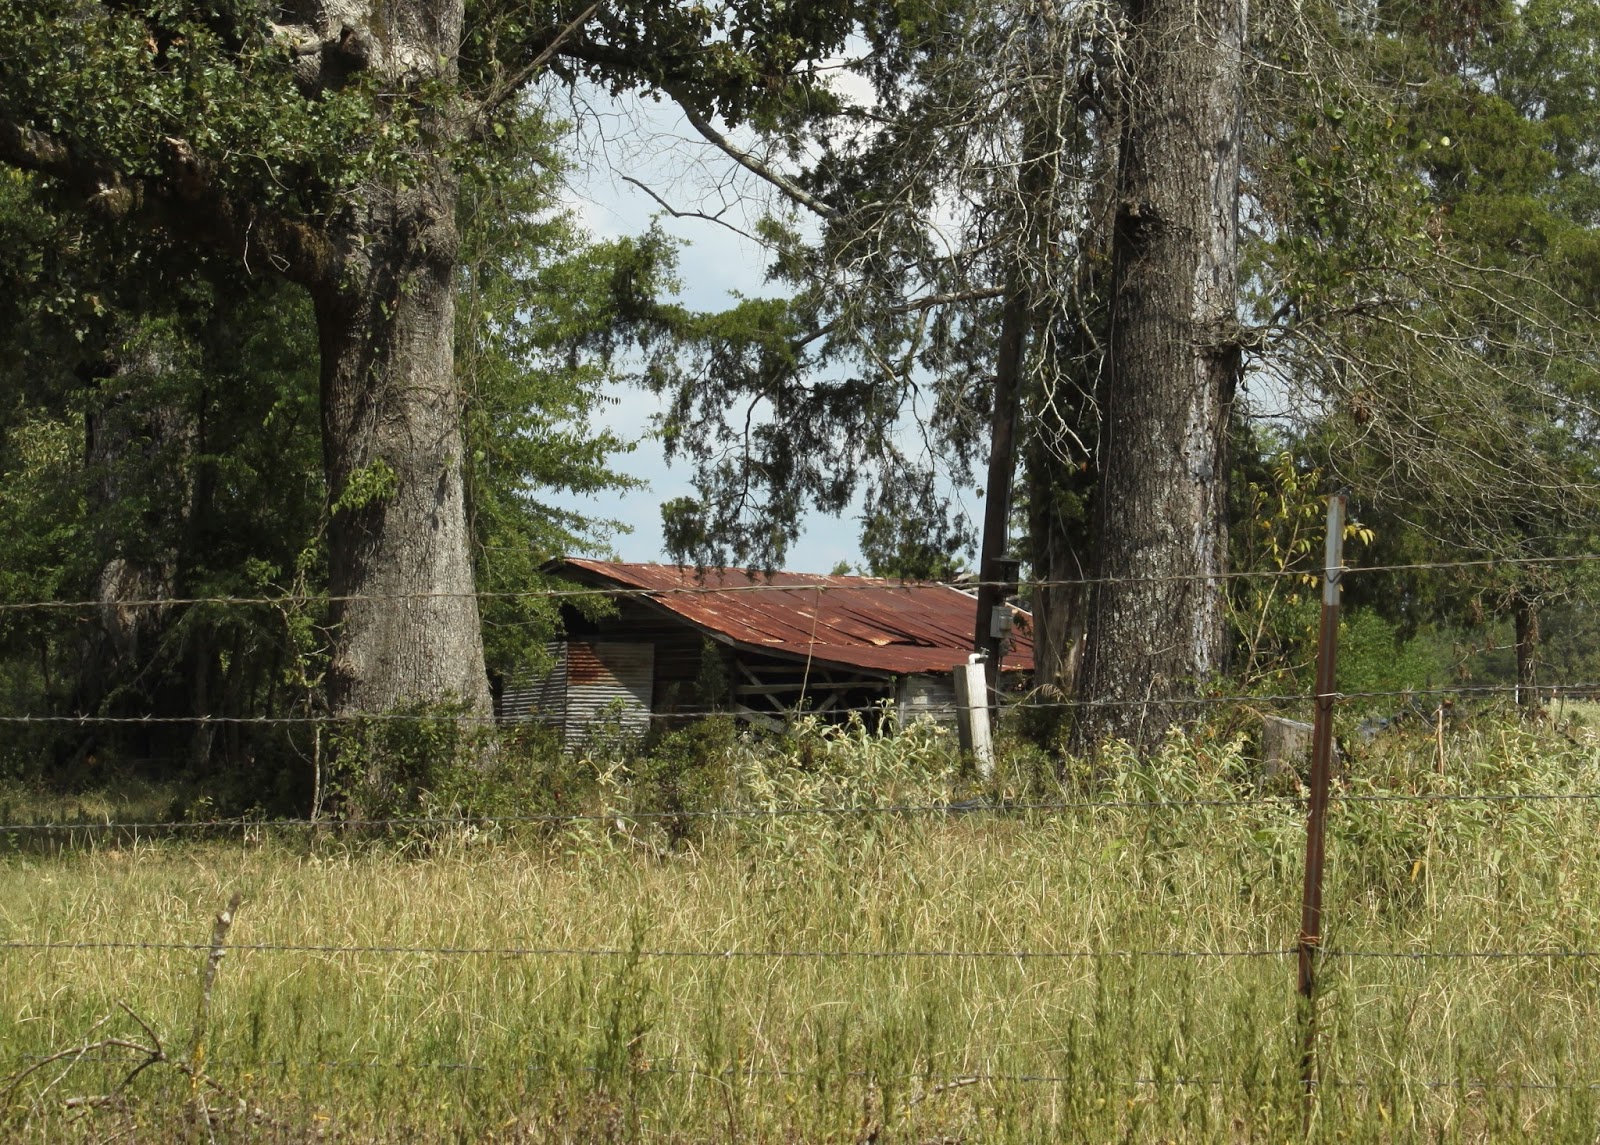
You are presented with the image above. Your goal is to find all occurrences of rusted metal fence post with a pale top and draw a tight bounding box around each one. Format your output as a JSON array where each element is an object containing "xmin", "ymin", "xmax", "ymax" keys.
[{"xmin": 1299, "ymin": 494, "xmax": 1344, "ymax": 1115}]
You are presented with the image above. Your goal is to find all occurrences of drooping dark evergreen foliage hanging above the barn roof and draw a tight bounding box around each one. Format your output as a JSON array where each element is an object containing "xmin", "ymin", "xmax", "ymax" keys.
[{"xmin": 617, "ymin": 0, "xmax": 1109, "ymax": 576}]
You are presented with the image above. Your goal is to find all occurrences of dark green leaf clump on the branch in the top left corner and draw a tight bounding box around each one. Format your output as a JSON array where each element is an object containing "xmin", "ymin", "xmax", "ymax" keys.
[{"xmin": 0, "ymin": 3, "xmax": 422, "ymax": 216}]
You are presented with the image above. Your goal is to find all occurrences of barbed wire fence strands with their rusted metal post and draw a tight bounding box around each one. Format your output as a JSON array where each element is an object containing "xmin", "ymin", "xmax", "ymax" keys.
[{"xmin": 0, "ymin": 499, "xmax": 1600, "ymax": 1119}]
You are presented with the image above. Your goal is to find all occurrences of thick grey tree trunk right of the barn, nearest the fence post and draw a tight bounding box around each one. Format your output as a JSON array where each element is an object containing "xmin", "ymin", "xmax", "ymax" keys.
[{"xmin": 1078, "ymin": 0, "xmax": 1245, "ymax": 748}]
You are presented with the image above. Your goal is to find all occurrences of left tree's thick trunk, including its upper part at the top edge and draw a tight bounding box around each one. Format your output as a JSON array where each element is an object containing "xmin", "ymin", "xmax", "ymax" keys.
[{"xmin": 276, "ymin": 0, "xmax": 490, "ymax": 726}]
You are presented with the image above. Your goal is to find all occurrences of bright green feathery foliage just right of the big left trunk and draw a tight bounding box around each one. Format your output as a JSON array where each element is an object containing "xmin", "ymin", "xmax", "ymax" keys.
[{"xmin": 456, "ymin": 115, "xmax": 649, "ymax": 675}]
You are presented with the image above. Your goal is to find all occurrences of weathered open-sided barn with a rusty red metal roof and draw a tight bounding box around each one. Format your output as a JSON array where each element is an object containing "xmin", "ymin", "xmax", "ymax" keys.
[{"xmin": 496, "ymin": 560, "xmax": 1034, "ymax": 742}]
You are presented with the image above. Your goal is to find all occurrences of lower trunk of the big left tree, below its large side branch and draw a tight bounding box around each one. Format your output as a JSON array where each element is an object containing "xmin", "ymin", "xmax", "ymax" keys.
[{"xmin": 317, "ymin": 176, "xmax": 488, "ymax": 715}]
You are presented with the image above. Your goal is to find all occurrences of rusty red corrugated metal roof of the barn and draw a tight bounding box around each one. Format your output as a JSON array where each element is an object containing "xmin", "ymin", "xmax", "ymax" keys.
[{"xmin": 557, "ymin": 558, "xmax": 1034, "ymax": 675}]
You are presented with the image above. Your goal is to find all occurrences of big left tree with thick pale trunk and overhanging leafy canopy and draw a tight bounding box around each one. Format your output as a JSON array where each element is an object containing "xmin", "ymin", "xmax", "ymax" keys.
[{"xmin": 0, "ymin": 0, "xmax": 853, "ymax": 738}]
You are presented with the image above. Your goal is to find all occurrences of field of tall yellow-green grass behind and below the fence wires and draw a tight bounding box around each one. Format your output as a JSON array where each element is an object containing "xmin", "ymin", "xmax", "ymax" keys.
[{"xmin": 0, "ymin": 721, "xmax": 1600, "ymax": 1142}]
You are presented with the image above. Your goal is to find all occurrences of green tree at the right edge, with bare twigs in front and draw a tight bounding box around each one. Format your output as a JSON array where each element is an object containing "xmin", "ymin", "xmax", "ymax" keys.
[{"xmin": 1254, "ymin": 2, "xmax": 1600, "ymax": 702}]
